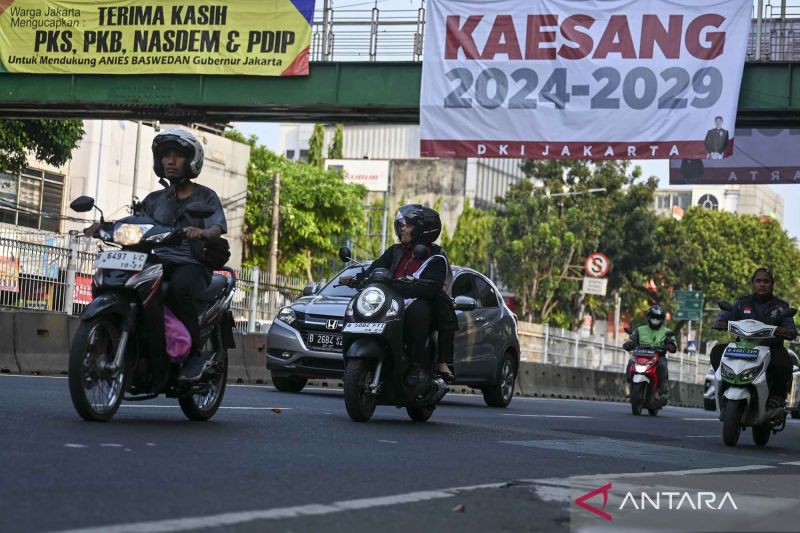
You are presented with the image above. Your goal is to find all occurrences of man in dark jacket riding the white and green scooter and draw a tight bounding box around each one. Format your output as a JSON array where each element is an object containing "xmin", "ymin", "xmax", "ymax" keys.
[{"xmin": 710, "ymin": 267, "xmax": 797, "ymax": 408}]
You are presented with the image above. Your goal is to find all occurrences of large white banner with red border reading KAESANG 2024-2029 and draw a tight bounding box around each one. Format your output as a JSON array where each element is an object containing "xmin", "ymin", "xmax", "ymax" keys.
[{"xmin": 420, "ymin": 0, "xmax": 752, "ymax": 159}]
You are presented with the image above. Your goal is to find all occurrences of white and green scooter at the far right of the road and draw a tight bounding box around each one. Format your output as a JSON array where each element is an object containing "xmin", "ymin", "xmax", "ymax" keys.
[{"xmin": 714, "ymin": 301, "xmax": 797, "ymax": 446}]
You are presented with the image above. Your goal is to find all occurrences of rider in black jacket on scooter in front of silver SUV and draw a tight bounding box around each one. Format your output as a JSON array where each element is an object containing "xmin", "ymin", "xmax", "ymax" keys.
[{"xmin": 339, "ymin": 204, "xmax": 458, "ymax": 385}]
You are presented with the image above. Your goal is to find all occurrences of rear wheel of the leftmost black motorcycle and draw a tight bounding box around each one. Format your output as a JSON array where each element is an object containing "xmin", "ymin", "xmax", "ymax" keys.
[{"xmin": 178, "ymin": 327, "xmax": 228, "ymax": 422}]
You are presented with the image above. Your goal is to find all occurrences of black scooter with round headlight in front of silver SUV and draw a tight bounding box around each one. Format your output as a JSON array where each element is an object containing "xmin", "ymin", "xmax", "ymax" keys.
[{"xmin": 339, "ymin": 246, "xmax": 449, "ymax": 422}]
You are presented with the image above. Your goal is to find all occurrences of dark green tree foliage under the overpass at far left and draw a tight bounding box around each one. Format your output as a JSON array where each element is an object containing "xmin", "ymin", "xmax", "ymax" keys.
[{"xmin": 0, "ymin": 120, "xmax": 85, "ymax": 174}]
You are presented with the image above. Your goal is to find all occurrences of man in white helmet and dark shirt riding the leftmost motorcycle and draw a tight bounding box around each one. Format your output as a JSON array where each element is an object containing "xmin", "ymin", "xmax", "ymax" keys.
[{"xmin": 141, "ymin": 128, "xmax": 227, "ymax": 381}]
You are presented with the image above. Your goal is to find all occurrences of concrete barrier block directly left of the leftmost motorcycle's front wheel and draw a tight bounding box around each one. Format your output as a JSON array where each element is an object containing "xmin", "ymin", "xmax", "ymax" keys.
[{"xmin": 14, "ymin": 311, "xmax": 69, "ymax": 374}]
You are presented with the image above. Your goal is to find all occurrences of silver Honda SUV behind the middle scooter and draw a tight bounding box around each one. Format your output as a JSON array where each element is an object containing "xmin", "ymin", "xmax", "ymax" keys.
[{"xmin": 267, "ymin": 267, "xmax": 520, "ymax": 407}]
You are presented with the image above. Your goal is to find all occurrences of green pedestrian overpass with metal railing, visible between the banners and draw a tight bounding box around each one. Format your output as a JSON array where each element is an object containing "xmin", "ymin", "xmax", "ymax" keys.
[{"xmin": 0, "ymin": 6, "xmax": 800, "ymax": 128}]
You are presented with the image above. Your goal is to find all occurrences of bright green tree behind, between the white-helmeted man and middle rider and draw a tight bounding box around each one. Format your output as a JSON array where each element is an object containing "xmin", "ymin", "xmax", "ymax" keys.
[{"xmin": 245, "ymin": 138, "xmax": 366, "ymax": 280}]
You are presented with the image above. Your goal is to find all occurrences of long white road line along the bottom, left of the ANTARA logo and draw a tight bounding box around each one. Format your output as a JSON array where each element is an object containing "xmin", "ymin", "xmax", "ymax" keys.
[{"xmin": 54, "ymin": 483, "xmax": 508, "ymax": 533}]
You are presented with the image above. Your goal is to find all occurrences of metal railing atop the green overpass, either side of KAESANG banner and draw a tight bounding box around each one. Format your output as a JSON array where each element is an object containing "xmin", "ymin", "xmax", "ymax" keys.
[{"xmin": 311, "ymin": 1, "xmax": 800, "ymax": 62}]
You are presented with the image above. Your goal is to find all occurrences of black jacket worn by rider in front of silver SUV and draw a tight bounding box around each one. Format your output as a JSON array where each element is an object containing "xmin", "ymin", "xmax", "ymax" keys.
[{"xmin": 359, "ymin": 243, "xmax": 458, "ymax": 330}]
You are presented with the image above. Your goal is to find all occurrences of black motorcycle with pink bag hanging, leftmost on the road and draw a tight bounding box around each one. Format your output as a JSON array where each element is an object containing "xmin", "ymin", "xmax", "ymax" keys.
[{"xmin": 69, "ymin": 196, "xmax": 236, "ymax": 421}]
